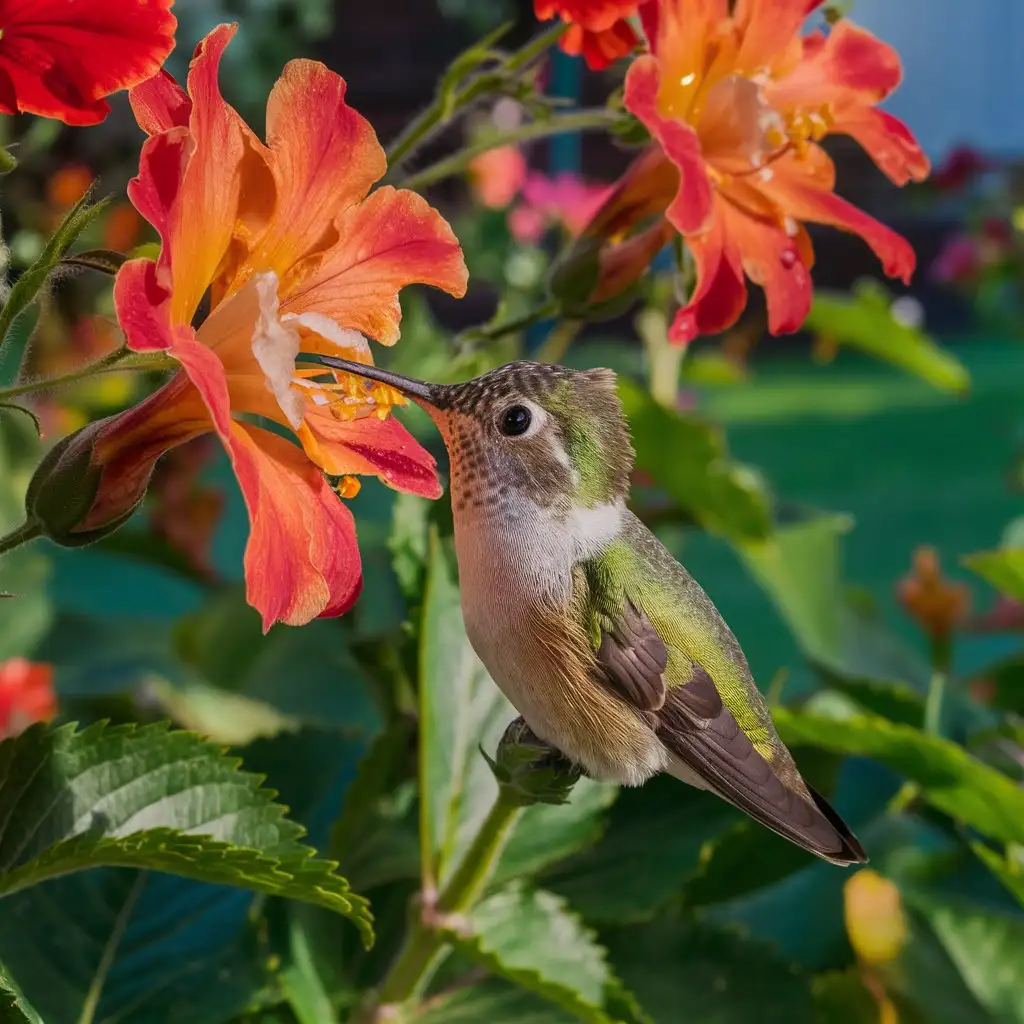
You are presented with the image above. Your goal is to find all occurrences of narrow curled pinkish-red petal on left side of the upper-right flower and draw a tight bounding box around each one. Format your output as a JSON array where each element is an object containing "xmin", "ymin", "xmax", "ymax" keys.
[{"xmin": 625, "ymin": 56, "xmax": 712, "ymax": 234}]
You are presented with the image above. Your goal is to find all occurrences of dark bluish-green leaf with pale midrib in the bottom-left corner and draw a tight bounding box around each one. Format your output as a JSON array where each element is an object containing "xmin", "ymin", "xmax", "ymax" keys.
[{"xmin": 0, "ymin": 869, "xmax": 271, "ymax": 1024}]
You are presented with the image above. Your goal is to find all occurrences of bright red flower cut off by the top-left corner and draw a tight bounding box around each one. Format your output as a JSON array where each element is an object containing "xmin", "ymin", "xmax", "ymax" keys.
[{"xmin": 0, "ymin": 0, "xmax": 177, "ymax": 125}]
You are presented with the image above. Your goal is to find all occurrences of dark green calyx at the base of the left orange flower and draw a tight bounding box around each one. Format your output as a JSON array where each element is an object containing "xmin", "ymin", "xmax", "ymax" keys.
[{"xmin": 25, "ymin": 418, "xmax": 153, "ymax": 548}]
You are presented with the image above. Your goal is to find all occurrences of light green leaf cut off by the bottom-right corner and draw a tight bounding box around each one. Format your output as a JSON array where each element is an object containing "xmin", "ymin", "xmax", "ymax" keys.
[{"xmin": 910, "ymin": 894, "xmax": 1024, "ymax": 1024}]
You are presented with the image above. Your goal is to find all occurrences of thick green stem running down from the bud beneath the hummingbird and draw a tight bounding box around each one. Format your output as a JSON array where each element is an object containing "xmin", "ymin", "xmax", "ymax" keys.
[{"xmin": 361, "ymin": 786, "xmax": 523, "ymax": 1021}]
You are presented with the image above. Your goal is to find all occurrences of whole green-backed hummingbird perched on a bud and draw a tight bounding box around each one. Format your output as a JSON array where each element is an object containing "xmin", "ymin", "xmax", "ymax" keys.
[{"xmin": 309, "ymin": 354, "xmax": 867, "ymax": 865}]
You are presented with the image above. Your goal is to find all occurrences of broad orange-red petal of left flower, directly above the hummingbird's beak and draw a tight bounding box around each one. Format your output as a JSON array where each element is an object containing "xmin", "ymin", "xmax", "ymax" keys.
[{"xmin": 282, "ymin": 186, "xmax": 468, "ymax": 345}]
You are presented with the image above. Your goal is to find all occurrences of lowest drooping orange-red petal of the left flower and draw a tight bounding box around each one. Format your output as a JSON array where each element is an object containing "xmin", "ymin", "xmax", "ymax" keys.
[{"xmin": 228, "ymin": 423, "xmax": 362, "ymax": 632}]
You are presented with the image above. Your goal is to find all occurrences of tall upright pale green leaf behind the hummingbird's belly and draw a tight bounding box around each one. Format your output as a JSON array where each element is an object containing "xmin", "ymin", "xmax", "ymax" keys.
[{"xmin": 420, "ymin": 536, "xmax": 515, "ymax": 885}]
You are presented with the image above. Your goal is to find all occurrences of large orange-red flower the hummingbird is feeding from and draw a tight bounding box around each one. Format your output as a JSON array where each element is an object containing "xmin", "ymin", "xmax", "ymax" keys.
[{"xmin": 78, "ymin": 26, "xmax": 466, "ymax": 629}]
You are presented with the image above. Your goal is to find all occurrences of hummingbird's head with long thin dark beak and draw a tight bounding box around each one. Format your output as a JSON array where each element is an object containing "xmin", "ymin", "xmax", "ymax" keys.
[{"xmin": 299, "ymin": 356, "xmax": 633, "ymax": 513}]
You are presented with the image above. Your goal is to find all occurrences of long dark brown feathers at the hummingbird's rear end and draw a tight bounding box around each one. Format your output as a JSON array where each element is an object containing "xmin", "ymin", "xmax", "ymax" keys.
[{"xmin": 656, "ymin": 670, "xmax": 867, "ymax": 865}]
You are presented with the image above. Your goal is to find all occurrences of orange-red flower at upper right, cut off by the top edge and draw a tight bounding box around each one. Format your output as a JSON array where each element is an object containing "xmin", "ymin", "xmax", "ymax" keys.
[{"xmin": 592, "ymin": 0, "xmax": 929, "ymax": 343}]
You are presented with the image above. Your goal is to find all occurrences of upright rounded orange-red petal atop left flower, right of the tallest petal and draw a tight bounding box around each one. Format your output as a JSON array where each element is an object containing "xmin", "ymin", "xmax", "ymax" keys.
[{"xmin": 250, "ymin": 60, "xmax": 387, "ymax": 278}]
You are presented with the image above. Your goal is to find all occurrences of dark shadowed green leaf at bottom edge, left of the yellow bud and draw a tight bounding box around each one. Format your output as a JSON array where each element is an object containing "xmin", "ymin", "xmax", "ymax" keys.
[{"xmin": 605, "ymin": 914, "xmax": 815, "ymax": 1024}]
